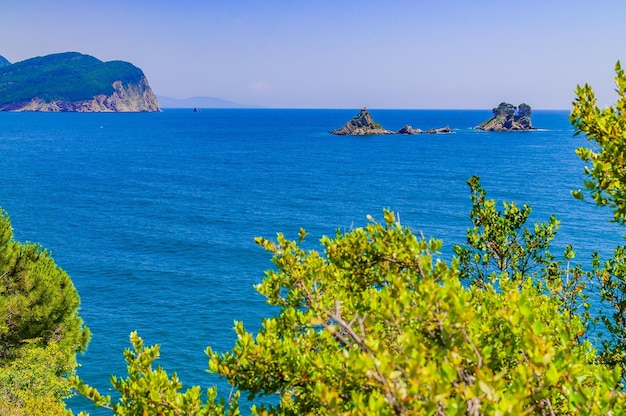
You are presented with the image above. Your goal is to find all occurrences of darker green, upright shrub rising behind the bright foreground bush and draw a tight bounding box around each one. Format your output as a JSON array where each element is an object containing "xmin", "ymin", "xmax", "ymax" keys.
[{"xmin": 453, "ymin": 176, "xmax": 593, "ymax": 320}]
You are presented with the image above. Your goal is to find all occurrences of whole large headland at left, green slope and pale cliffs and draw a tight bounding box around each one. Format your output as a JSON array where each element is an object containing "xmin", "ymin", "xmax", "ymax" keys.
[{"xmin": 0, "ymin": 52, "xmax": 160, "ymax": 112}]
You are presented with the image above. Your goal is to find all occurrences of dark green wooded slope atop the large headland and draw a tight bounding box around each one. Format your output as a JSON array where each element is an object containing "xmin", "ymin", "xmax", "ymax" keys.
[{"xmin": 0, "ymin": 52, "xmax": 144, "ymax": 106}]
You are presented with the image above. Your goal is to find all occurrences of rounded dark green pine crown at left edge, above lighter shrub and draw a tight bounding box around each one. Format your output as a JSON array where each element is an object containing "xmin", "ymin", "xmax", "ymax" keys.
[{"xmin": 0, "ymin": 211, "xmax": 89, "ymax": 363}]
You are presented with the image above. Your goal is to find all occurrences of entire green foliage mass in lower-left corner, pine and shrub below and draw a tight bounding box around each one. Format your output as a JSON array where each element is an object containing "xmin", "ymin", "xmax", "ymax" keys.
[{"xmin": 0, "ymin": 211, "xmax": 89, "ymax": 414}]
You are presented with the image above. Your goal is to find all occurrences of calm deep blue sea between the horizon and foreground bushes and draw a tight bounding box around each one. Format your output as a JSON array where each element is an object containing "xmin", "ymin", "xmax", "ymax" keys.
[{"xmin": 0, "ymin": 109, "xmax": 624, "ymax": 414}]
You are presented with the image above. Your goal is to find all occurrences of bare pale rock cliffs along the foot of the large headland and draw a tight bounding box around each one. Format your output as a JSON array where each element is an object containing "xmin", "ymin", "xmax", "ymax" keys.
[{"xmin": 10, "ymin": 77, "xmax": 160, "ymax": 113}]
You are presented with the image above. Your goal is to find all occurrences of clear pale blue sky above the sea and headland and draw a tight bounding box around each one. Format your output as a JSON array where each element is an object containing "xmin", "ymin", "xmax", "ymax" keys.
[{"xmin": 0, "ymin": 0, "xmax": 626, "ymax": 109}]
